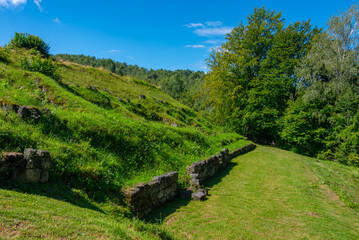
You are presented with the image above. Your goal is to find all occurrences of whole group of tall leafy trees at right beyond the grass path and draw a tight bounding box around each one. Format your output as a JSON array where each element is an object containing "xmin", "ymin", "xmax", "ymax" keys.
[{"xmin": 203, "ymin": 5, "xmax": 359, "ymax": 166}]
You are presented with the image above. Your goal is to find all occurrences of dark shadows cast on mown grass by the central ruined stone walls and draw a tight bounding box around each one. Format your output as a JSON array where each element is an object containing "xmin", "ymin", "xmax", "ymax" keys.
[{"xmin": 144, "ymin": 162, "xmax": 238, "ymax": 223}]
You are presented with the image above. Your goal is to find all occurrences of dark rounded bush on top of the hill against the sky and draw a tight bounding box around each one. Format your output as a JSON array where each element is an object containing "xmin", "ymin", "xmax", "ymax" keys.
[{"xmin": 9, "ymin": 32, "xmax": 50, "ymax": 57}]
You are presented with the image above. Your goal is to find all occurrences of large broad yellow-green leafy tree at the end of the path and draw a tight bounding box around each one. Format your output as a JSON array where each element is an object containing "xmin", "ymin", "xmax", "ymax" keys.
[{"xmin": 205, "ymin": 7, "xmax": 319, "ymax": 143}]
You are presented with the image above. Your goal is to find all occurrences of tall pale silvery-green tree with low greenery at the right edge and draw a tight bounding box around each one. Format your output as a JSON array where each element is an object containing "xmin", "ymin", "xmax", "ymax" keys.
[{"xmin": 281, "ymin": 4, "xmax": 359, "ymax": 165}]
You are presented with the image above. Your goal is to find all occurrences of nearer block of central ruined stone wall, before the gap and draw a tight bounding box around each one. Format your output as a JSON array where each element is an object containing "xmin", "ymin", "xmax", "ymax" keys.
[{"xmin": 124, "ymin": 172, "xmax": 178, "ymax": 217}]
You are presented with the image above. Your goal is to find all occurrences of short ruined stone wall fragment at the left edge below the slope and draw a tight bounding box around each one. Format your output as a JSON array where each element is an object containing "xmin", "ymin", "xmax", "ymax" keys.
[{"xmin": 0, "ymin": 148, "xmax": 51, "ymax": 183}]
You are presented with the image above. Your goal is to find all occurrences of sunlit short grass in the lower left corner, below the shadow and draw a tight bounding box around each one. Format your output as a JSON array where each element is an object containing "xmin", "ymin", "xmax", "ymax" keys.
[{"xmin": 0, "ymin": 186, "xmax": 173, "ymax": 240}]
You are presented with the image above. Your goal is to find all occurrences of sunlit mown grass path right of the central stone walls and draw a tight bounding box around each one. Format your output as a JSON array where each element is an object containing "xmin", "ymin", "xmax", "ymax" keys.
[{"xmin": 163, "ymin": 146, "xmax": 359, "ymax": 239}]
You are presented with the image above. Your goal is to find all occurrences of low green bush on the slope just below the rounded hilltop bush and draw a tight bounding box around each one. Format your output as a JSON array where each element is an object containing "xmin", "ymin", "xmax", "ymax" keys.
[{"xmin": 21, "ymin": 56, "xmax": 60, "ymax": 80}]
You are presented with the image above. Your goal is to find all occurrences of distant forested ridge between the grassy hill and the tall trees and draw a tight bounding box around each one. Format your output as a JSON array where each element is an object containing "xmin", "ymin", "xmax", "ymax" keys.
[{"xmin": 55, "ymin": 54, "xmax": 205, "ymax": 108}]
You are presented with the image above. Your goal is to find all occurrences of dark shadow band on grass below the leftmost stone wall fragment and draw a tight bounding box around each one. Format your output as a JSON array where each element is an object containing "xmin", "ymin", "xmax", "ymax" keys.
[{"xmin": 0, "ymin": 179, "xmax": 104, "ymax": 213}]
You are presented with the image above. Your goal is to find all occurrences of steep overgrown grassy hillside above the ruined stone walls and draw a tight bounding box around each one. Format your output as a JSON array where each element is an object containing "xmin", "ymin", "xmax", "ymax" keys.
[{"xmin": 0, "ymin": 45, "xmax": 248, "ymax": 200}]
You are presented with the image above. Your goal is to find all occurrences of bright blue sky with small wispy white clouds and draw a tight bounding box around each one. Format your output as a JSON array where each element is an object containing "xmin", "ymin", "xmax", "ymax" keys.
[{"xmin": 0, "ymin": 0, "xmax": 357, "ymax": 70}]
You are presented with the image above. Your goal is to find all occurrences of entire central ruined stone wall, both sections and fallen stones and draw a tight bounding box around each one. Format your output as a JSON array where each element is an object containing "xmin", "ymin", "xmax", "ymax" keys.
[{"xmin": 124, "ymin": 143, "xmax": 256, "ymax": 217}]
